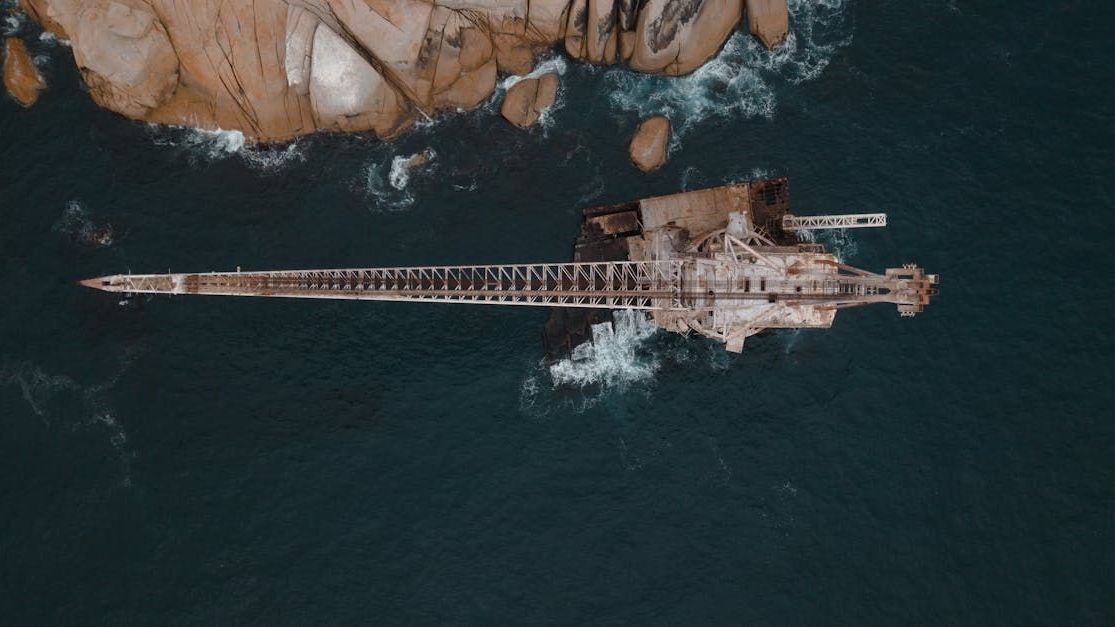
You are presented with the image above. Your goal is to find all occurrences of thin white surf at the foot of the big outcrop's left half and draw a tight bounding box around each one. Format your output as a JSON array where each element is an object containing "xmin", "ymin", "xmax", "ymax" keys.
[{"xmin": 148, "ymin": 124, "xmax": 306, "ymax": 173}]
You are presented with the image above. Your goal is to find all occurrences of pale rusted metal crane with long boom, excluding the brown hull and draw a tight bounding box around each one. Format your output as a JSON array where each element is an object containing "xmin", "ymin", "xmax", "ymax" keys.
[{"xmin": 81, "ymin": 196, "xmax": 938, "ymax": 353}]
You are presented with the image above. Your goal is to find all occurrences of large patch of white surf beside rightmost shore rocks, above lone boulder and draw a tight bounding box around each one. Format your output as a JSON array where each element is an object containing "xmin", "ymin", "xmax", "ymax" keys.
[{"xmin": 604, "ymin": 0, "xmax": 852, "ymax": 135}]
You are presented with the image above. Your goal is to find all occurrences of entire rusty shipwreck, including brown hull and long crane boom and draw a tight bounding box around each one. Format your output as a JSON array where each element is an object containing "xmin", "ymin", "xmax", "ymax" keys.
[{"xmin": 80, "ymin": 177, "xmax": 938, "ymax": 356}]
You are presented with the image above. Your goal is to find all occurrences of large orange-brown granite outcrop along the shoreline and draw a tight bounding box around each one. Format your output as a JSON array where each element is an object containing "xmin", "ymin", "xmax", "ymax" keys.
[{"xmin": 20, "ymin": 0, "xmax": 785, "ymax": 141}]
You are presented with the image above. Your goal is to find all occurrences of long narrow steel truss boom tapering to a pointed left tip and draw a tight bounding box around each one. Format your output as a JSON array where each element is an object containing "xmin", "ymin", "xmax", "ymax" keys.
[{"xmin": 81, "ymin": 251, "xmax": 935, "ymax": 311}]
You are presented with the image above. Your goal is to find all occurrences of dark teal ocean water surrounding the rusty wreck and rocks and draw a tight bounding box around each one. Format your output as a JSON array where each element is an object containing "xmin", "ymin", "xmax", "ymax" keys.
[{"xmin": 0, "ymin": 0, "xmax": 1115, "ymax": 625}]
